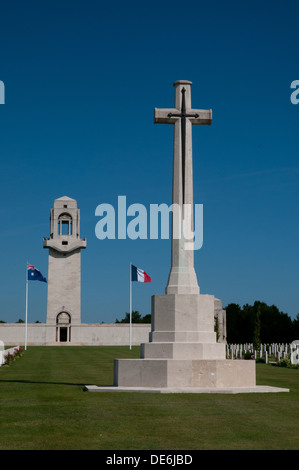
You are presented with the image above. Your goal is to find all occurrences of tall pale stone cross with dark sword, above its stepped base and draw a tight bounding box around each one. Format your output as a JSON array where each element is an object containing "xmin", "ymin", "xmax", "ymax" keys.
[{"xmin": 154, "ymin": 80, "xmax": 212, "ymax": 294}]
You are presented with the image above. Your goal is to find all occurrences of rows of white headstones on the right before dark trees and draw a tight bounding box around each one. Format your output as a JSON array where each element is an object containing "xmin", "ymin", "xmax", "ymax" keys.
[{"xmin": 226, "ymin": 341, "xmax": 299, "ymax": 365}]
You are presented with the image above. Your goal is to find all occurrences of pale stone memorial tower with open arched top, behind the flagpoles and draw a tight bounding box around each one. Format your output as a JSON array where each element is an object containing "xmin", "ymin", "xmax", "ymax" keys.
[{"xmin": 44, "ymin": 196, "xmax": 86, "ymax": 342}]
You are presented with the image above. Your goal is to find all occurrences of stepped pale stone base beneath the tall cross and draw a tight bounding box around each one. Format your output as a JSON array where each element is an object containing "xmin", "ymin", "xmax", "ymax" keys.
[{"xmin": 85, "ymin": 294, "xmax": 288, "ymax": 393}]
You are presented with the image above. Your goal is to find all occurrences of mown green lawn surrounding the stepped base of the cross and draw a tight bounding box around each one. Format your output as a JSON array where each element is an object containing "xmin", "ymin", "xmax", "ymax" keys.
[{"xmin": 0, "ymin": 346, "xmax": 299, "ymax": 450}]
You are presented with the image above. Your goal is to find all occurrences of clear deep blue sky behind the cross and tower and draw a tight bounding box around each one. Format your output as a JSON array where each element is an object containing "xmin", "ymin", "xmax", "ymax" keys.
[{"xmin": 0, "ymin": 0, "xmax": 299, "ymax": 323}]
